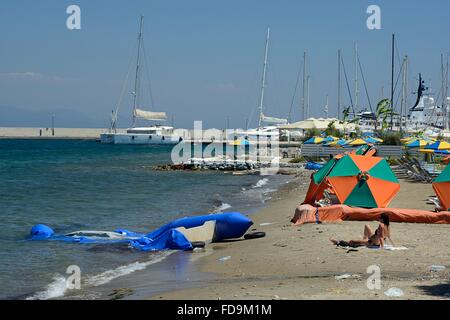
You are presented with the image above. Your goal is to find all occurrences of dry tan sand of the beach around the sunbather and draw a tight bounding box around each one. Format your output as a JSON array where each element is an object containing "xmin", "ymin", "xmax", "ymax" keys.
[{"xmin": 150, "ymin": 172, "xmax": 450, "ymax": 300}]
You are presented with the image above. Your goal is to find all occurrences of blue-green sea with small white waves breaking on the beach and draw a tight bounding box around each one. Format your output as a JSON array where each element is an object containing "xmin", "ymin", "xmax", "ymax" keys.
[{"xmin": 0, "ymin": 139, "xmax": 289, "ymax": 300}]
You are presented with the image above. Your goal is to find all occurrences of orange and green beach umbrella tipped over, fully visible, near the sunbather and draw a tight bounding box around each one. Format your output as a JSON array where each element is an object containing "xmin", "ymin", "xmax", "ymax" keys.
[{"xmin": 326, "ymin": 154, "xmax": 400, "ymax": 208}]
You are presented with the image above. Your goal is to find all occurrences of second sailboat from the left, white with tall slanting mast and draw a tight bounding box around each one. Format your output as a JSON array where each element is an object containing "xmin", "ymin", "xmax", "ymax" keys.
[{"xmin": 232, "ymin": 28, "xmax": 288, "ymax": 139}]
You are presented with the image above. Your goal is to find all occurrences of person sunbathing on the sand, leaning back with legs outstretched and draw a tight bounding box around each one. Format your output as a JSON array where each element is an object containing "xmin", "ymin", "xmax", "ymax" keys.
[{"xmin": 330, "ymin": 213, "xmax": 394, "ymax": 249}]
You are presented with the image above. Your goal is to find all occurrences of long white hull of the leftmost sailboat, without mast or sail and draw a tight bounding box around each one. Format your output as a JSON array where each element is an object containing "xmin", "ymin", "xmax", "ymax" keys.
[{"xmin": 100, "ymin": 133, "xmax": 183, "ymax": 145}]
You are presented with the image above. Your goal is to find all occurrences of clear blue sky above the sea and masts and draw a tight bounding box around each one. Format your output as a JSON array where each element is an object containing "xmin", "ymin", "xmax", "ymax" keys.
[{"xmin": 0, "ymin": 0, "xmax": 450, "ymax": 128}]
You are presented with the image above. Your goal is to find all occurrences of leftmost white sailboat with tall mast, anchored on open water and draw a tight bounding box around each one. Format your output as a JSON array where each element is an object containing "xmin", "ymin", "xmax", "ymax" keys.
[{"xmin": 100, "ymin": 16, "xmax": 183, "ymax": 144}]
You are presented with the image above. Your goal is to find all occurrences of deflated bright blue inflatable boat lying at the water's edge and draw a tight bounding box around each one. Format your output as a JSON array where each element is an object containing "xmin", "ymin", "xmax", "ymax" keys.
[{"xmin": 30, "ymin": 212, "xmax": 253, "ymax": 251}]
